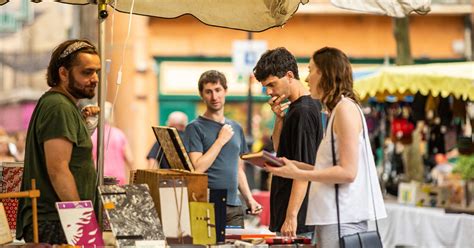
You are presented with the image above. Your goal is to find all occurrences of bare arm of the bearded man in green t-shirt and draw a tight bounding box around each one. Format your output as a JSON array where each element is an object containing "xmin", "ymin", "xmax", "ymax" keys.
[{"xmin": 44, "ymin": 138, "xmax": 81, "ymax": 201}]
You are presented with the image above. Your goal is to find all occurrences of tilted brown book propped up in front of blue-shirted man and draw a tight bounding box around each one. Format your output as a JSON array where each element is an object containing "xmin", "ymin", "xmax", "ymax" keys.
[{"xmin": 152, "ymin": 126, "xmax": 194, "ymax": 172}]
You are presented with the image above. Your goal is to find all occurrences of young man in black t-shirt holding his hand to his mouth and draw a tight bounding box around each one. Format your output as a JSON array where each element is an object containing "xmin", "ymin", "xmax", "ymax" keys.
[{"xmin": 254, "ymin": 48, "xmax": 323, "ymax": 236}]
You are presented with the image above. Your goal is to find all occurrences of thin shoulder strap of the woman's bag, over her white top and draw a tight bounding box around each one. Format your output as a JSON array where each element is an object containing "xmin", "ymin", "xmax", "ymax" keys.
[{"xmin": 331, "ymin": 103, "xmax": 379, "ymax": 239}]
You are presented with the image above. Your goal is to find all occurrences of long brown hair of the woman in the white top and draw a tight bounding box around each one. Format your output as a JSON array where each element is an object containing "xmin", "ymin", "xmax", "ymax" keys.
[{"xmin": 312, "ymin": 47, "xmax": 359, "ymax": 111}]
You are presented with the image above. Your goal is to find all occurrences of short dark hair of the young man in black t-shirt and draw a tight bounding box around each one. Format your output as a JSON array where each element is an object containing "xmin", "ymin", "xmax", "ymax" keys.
[{"xmin": 253, "ymin": 47, "xmax": 300, "ymax": 82}]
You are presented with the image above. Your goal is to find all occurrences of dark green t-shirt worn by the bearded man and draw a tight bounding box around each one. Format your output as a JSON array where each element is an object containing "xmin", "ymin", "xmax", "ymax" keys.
[{"xmin": 16, "ymin": 91, "xmax": 97, "ymax": 239}]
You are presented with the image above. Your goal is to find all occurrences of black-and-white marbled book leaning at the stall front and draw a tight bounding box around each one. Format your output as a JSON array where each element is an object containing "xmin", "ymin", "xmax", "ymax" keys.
[{"xmin": 99, "ymin": 184, "xmax": 165, "ymax": 247}]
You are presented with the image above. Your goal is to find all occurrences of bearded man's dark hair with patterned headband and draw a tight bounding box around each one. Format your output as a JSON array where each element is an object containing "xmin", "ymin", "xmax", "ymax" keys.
[{"xmin": 46, "ymin": 39, "xmax": 98, "ymax": 87}]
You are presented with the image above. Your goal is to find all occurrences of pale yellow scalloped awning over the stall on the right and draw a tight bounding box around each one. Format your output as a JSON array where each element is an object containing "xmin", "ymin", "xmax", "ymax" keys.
[{"xmin": 354, "ymin": 62, "xmax": 474, "ymax": 100}]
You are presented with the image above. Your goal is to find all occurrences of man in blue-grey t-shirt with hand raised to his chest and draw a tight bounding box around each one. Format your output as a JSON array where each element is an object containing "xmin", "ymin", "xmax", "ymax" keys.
[{"xmin": 184, "ymin": 70, "xmax": 262, "ymax": 227}]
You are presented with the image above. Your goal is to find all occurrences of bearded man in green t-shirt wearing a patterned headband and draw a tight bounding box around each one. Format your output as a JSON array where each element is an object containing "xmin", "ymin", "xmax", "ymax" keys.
[{"xmin": 16, "ymin": 40, "xmax": 100, "ymax": 244}]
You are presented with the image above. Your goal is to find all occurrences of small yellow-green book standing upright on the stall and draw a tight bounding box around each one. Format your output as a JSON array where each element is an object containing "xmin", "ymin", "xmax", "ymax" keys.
[{"xmin": 189, "ymin": 202, "xmax": 216, "ymax": 245}]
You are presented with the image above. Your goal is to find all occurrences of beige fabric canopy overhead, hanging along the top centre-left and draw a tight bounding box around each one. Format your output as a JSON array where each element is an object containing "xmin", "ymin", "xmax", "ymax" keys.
[{"xmin": 0, "ymin": 0, "xmax": 309, "ymax": 32}]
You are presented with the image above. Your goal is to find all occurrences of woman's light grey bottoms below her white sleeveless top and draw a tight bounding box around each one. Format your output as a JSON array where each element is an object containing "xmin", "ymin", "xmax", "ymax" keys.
[{"xmin": 315, "ymin": 221, "xmax": 368, "ymax": 248}]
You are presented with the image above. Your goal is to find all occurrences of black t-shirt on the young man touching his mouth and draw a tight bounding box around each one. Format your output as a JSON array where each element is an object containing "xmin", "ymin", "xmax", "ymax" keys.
[{"xmin": 270, "ymin": 96, "xmax": 323, "ymax": 233}]
